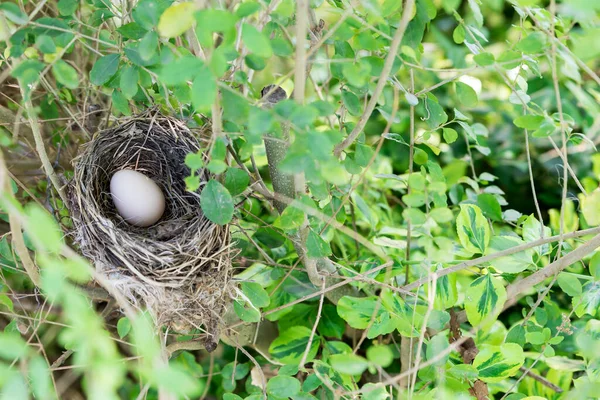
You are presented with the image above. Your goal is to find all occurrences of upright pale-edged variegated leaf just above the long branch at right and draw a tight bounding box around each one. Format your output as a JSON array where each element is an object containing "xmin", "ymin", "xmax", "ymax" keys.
[{"xmin": 456, "ymin": 204, "xmax": 490, "ymax": 254}]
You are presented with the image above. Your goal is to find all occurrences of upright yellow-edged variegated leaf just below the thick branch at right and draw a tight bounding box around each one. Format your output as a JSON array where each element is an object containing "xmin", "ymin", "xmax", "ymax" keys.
[{"xmin": 465, "ymin": 274, "xmax": 506, "ymax": 329}]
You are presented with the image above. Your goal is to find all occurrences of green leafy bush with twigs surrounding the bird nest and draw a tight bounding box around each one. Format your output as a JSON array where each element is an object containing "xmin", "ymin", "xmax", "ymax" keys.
[{"xmin": 0, "ymin": 0, "xmax": 600, "ymax": 400}]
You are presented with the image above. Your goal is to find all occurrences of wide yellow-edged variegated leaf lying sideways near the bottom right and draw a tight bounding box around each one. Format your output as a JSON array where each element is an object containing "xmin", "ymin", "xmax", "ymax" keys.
[{"xmin": 473, "ymin": 343, "xmax": 525, "ymax": 383}]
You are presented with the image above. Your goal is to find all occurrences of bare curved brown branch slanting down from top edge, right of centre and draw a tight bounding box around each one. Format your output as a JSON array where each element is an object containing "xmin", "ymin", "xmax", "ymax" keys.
[{"xmin": 333, "ymin": 0, "xmax": 415, "ymax": 157}]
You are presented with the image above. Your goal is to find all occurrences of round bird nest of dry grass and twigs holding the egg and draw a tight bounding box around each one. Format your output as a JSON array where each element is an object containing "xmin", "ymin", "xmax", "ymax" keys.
[{"xmin": 70, "ymin": 110, "xmax": 231, "ymax": 349}]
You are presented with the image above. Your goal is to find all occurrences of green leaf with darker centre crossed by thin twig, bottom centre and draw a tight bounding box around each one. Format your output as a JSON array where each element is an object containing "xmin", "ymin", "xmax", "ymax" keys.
[{"xmin": 269, "ymin": 326, "xmax": 319, "ymax": 364}]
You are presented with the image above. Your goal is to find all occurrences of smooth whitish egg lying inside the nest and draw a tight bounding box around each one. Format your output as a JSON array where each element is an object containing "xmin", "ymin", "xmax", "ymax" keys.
[{"xmin": 110, "ymin": 169, "xmax": 165, "ymax": 227}]
